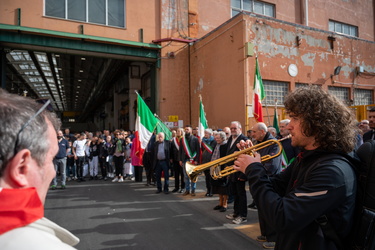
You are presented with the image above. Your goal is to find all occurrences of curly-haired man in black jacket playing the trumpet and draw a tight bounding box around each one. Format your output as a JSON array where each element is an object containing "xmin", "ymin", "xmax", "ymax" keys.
[{"xmin": 235, "ymin": 87, "xmax": 356, "ymax": 250}]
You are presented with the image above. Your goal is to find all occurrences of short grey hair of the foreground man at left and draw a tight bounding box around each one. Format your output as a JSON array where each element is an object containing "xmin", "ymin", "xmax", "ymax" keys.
[{"xmin": 0, "ymin": 89, "xmax": 61, "ymax": 177}]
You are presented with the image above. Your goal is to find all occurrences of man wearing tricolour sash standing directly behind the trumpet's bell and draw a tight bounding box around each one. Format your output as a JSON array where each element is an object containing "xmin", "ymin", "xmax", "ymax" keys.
[{"xmin": 180, "ymin": 125, "xmax": 200, "ymax": 196}]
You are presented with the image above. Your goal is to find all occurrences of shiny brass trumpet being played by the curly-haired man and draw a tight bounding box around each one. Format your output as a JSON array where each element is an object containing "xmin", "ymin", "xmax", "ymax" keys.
[{"xmin": 185, "ymin": 136, "xmax": 291, "ymax": 182}]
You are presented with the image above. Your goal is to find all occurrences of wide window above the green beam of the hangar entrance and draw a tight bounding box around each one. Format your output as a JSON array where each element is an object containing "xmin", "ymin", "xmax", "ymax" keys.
[{"xmin": 45, "ymin": 0, "xmax": 125, "ymax": 28}]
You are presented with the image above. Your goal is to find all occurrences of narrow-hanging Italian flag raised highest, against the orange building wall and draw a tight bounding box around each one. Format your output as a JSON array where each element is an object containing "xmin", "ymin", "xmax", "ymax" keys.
[{"xmin": 253, "ymin": 58, "xmax": 266, "ymax": 122}]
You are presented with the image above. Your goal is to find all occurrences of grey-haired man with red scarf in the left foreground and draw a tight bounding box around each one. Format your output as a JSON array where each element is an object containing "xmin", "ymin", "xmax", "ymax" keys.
[{"xmin": 0, "ymin": 90, "xmax": 79, "ymax": 250}]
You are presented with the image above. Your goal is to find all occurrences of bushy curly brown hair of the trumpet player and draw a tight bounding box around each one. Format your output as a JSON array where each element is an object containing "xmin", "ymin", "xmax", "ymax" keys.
[{"xmin": 284, "ymin": 86, "xmax": 357, "ymax": 153}]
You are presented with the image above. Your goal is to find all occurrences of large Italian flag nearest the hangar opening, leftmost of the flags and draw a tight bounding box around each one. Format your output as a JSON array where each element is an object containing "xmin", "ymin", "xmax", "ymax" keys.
[{"xmin": 132, "ymin": 93, "xmax": 158, "ymax": 165}]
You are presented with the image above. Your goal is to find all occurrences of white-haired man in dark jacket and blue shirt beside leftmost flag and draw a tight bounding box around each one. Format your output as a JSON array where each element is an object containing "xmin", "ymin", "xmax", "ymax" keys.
[{"xmin": 154, "ymin": 132, "xmax": 171, "ymax": 194}]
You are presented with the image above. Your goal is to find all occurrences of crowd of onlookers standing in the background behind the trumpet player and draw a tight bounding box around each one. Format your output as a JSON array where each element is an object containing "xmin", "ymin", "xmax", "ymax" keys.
[{"xmin": 51, "ymin": 95, "xmax": 374, "ymax": 249}]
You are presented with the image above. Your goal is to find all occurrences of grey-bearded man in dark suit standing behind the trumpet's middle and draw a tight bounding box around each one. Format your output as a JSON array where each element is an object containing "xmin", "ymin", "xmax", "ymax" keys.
[{"xmin": 226, "ymin": 121, "xmax": 247, "ymax": 224}]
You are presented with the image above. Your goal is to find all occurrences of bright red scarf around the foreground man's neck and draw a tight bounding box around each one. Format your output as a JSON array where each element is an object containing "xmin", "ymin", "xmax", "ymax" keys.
[{"xmin": 0, "ymin": 188, "xmax": 44, "ymax": 235}]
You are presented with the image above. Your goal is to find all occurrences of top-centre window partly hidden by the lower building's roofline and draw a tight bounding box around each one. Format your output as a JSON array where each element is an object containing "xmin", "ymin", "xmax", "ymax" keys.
[{"xmin": 231, "ymin": 0, "xmax": 275, "ymax": 17}]
